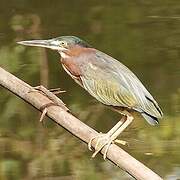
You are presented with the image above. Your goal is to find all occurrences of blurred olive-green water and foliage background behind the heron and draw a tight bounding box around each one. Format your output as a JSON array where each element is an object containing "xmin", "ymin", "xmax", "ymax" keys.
[{"xmin": 0, "ymin": 0, "xmax": 180, "ymax": 180}]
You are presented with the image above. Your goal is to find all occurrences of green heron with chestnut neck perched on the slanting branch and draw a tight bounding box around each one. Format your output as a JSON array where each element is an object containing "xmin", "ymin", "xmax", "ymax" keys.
[{"xmin": 19, "ymin": 36, "xmax": 163, "ymax": 158}]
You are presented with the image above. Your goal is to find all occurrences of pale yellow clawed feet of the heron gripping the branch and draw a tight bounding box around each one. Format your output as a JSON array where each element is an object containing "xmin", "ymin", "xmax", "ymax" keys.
[{"xmin": 88, "ymin": 133, "xmax": 127, "ymax": 160}]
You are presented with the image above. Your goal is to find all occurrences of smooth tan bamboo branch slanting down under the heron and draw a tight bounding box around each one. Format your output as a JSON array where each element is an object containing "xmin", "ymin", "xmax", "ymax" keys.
[{"xmin": 0, "ymin": 67, "xmax": 162, "ymax": 180}]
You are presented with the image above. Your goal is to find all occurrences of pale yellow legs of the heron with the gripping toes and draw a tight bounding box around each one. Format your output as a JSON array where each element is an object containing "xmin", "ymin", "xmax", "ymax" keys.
[{"xmin": 91, "ymin": 111, "xmax": 133, "ymax": 159}]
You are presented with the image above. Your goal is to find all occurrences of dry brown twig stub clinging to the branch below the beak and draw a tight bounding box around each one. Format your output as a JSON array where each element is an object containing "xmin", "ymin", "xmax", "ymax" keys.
[{"xmin": 29, "ymin": 85, "xmax": 69, "ymax": 122}]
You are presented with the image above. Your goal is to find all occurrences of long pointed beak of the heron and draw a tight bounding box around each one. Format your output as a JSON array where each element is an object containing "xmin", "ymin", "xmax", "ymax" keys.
[{"xmin": 17, "ymin": 39, "xmax": 64, "ymax": 51}]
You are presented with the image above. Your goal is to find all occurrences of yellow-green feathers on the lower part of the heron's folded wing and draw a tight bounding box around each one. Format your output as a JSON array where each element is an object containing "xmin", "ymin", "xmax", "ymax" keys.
[{"xmin": 81, "ymin": 77, "xmax": 136, "ymax": 108}]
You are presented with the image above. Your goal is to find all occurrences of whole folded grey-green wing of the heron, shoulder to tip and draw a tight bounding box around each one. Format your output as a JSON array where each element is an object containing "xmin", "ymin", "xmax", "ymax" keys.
[{"xmin": 78, "ymin": 51, "xmax": 162, "ymax": 118}]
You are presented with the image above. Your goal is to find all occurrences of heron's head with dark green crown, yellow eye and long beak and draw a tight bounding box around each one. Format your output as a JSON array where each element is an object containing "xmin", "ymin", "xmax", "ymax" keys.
[{"xmin": 18, "ymin": 36, "xmax": 90, "ymax": 54}]
